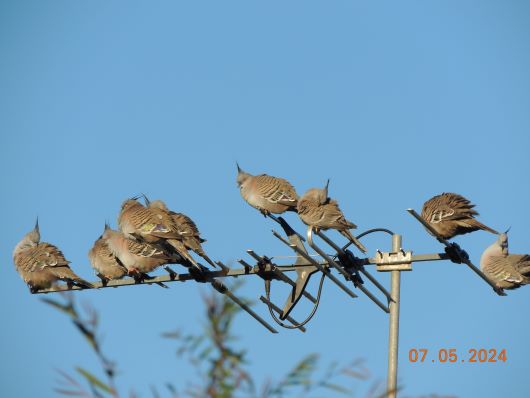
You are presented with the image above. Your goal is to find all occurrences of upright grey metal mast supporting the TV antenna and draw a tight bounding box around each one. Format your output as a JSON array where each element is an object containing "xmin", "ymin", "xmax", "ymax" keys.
[{"xmin": 386, "ymin": 234, "xmax": 401, "ymax": 398}]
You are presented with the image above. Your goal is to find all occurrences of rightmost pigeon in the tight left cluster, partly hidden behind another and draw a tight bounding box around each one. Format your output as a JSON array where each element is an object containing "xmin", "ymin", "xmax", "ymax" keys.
[{"xmin": 143, "ymin": 195, "xmax": 217, "ymax": 270}]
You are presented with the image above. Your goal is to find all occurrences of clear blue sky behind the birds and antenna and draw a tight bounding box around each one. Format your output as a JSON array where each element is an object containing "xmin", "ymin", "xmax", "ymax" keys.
[{"xmin": 0, "ymin": 0, "xmax": 530, "ymax": 397}]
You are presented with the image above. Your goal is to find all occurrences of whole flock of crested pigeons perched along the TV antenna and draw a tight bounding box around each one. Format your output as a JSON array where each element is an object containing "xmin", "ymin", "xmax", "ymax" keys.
[{"xmin": 13, "ymin": 165, "xmax": 530, "ymax": 292}]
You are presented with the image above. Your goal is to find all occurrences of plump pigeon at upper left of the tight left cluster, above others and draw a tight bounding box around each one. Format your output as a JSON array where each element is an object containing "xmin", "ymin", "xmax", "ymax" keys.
[{"xmin": 118, "ymin": 197, "xmax": 180, "ymax": 243}]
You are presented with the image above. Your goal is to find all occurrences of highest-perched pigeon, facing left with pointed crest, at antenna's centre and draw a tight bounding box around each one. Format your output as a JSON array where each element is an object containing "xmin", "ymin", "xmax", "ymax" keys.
[{"xmin": 236, "ymin": 163, "xmax": 298, "ymax": 216}]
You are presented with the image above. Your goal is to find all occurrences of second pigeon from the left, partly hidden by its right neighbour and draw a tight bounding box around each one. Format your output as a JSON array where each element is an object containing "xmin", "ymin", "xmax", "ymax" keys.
[{"xmin": 88, "ymin": 224, "xmax": 128, "ymax": 286}]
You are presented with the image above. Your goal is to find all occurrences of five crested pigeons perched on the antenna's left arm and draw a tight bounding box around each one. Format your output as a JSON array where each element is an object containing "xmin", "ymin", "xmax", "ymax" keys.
[{"xmin": 13, "ymin": 195, "xmax": 215, "ymax": 293}]
